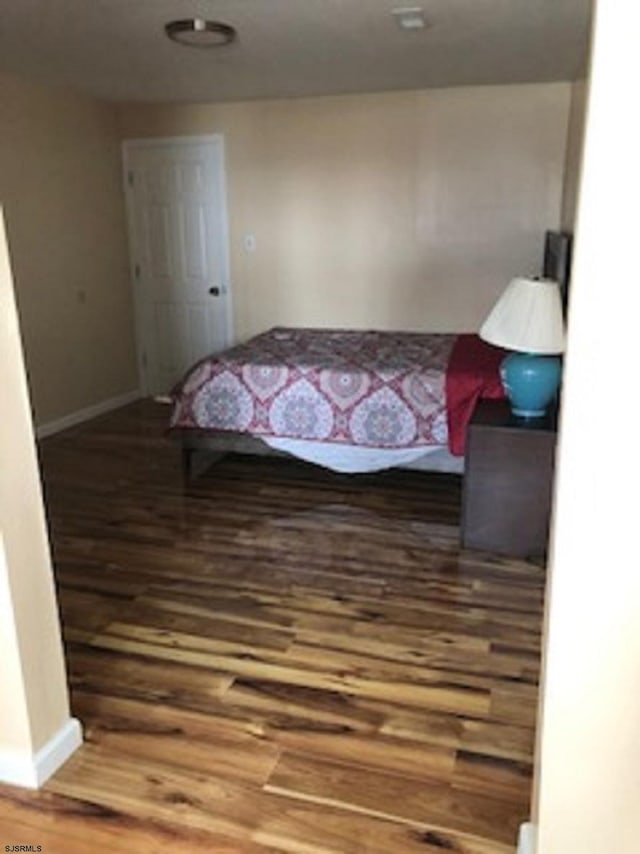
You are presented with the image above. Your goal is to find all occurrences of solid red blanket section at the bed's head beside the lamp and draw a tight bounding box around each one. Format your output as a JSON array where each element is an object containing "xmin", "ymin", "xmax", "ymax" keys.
[{"xmin": 445, "ymin": 335, "xmax": 507, "ymax": 456}]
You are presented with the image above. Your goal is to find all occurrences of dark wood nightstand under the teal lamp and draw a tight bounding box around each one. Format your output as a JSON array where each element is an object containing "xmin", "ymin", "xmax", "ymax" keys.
[{"xmin": 461, "ymin": 400, "xmax": 556, "ymax": 557}]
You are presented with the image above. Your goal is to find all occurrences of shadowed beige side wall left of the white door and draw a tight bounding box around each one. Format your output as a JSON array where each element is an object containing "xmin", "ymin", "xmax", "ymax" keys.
[{"xmin": 0, "ymin": 74, "xmax": 137, "ymax": 423}]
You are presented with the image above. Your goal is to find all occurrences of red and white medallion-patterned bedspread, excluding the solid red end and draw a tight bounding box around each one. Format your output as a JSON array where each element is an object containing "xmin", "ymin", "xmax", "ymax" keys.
[{"xmin": 171, "ymin": 328, "xmax": 456, "ymax": 448}]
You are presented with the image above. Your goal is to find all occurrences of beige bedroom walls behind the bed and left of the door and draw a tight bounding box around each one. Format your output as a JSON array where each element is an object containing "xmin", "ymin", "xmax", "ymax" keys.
[{"xmin": 0, "ymin": 75, "xmax": 576, "ymax": 424}]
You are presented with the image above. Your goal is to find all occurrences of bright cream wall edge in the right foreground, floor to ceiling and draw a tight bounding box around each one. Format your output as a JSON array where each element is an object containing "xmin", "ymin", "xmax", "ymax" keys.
[{"xmin": 537, "ymin": 0, "xmax": 640, "ymax": 854}]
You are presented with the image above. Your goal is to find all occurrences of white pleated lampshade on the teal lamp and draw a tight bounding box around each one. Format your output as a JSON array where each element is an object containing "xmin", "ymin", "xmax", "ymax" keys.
[{"xmin": 480, "ymin": 278, "xmax": 564, "ymax": 355}]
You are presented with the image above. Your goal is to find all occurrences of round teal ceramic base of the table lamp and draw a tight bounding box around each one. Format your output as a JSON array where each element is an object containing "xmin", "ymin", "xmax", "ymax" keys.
[{"xmin": 500, "ymin": 353, "xmax": 561, "ymax": 418}]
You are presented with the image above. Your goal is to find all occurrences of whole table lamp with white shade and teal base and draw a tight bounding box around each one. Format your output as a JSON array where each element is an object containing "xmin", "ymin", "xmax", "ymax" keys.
[{"xmin": 480, "ymin": 277, "xmax": 564, "ymax": 418}]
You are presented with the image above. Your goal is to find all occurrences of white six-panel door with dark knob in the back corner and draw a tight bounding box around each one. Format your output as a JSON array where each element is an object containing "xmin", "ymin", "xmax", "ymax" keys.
[{"xmin": 124, "ymin": 136, "xmax": 231, "ymax": 395}]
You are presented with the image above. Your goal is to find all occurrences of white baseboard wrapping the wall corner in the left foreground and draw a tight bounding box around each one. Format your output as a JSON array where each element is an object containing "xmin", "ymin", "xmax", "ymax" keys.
[{"xmin": 0, "ymin": 718, "xmax": 82, "ymax": 789}]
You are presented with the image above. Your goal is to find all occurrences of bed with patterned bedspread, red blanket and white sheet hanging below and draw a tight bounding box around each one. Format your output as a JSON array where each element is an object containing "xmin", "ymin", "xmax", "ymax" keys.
[{"xmin": 171, "ymin": 327, "xmax": 504, "ymax": 473}]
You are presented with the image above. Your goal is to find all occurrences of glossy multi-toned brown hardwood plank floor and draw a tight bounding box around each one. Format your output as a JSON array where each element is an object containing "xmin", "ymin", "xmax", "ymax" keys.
[{"xmin": 0, "ymin": 402, "xmax": 544, "ymax": 854}]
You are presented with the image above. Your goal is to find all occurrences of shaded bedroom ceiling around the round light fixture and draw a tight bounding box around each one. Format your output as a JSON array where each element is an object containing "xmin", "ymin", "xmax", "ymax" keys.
[{"xmin": 0, "ymin": 0, "xmax": 591, "ymax": 101}]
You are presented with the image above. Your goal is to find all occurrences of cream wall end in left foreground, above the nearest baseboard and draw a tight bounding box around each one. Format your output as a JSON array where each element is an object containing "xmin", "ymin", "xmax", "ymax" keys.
[{"xmin": 0, "ymin": 214, "xmax": 69, "ymax": 760}]
